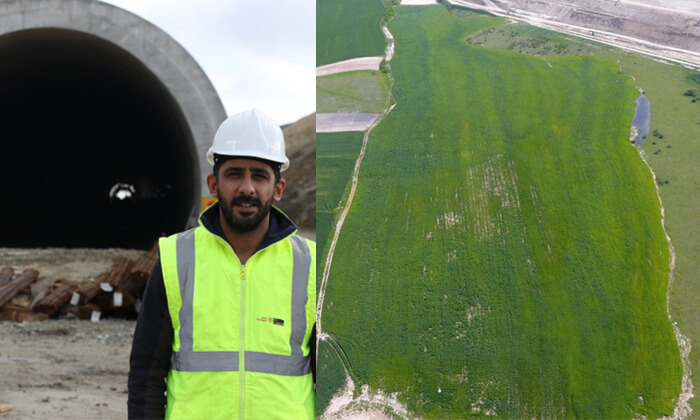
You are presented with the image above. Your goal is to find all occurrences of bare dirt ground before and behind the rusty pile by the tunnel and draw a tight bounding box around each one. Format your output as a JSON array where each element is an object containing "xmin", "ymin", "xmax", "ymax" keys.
[{"xmin": 0, "ymin": 248, "xmax": 143, "ymax": 420}]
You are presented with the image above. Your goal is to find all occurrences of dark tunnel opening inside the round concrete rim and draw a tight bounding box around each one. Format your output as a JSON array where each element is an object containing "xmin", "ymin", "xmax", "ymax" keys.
[{"xmin": 0, "ymin": 29, "xmax": 198, "ymax": 249}]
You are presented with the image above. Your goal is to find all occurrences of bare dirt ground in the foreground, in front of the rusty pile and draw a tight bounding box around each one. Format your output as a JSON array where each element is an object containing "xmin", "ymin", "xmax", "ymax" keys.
[{"xmin": 0, "ymin": 320, "xmax": 135, "ymax": 419}]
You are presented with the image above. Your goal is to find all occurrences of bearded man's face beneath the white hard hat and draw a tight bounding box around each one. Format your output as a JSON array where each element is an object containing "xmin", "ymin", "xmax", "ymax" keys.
[{"xmin": 207, "ymin": 158, "xmax": 285, "ymax": 233}]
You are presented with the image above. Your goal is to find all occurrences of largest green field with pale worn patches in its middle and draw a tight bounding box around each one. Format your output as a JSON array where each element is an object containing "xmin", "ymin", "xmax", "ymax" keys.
[{"xmin": 318, "ymin": 6, "xmax": 684, "ymax": 418}]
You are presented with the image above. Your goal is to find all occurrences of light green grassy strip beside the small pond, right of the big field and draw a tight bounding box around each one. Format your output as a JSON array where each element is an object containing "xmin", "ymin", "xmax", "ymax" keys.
[{"xmin": 600, "ymin": 54, "xmax": 700, "ymax": 418}]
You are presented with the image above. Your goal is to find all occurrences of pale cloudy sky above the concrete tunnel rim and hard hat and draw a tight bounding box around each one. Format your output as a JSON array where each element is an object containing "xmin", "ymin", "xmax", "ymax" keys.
[{"xmin": 103, "ymin": 0, "xmax": 316, "ymax": 125}]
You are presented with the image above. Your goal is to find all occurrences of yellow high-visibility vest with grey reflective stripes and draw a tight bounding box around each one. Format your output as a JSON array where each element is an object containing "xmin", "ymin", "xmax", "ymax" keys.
[{"xmin": 160, "ymin": 220, "xmax": 316, "ymax": 419}]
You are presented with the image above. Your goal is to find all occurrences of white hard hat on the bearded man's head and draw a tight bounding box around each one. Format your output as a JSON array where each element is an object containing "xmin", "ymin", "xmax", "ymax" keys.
[{"xmin": 207, "ymin": 109, "xmax": 289, "ymax": 171}]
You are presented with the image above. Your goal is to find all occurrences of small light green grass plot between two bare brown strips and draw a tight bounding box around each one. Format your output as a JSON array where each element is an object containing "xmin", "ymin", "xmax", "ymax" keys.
[{"xmin": 316, "ymin": 70, "xmax": 389, "ymax": 113}]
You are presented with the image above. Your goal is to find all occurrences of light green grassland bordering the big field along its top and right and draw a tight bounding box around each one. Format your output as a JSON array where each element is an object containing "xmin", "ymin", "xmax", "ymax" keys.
[{"xmin": 455, "ymin": 13, "xmax": 700, "ymax": 417}]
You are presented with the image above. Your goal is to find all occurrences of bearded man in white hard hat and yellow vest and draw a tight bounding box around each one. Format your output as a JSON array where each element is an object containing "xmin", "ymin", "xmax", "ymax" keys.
[{"xmin": 128, "ymin": 110, "xmax": 316, "ymax": 419}]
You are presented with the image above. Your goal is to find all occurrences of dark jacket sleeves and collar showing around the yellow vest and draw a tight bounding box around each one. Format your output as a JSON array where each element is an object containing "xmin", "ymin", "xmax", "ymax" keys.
[{"xmin": 127, "ymin": 203, "xmax": 316, "ymax": 419}]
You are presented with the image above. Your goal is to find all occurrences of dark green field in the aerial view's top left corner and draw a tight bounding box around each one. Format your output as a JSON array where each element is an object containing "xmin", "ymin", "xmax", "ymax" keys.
[{"xmin": 316, "ymin": 0, "xmax": 386, "ymax": 66}]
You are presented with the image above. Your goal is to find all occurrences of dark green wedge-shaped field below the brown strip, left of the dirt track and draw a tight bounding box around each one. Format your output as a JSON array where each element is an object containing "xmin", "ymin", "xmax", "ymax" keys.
[{"xmin": 316, "ymin": 132, "xmax": 363, "ymax": 277}]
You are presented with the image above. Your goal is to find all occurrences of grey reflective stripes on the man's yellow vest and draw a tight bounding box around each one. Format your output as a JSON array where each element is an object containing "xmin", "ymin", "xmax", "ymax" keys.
[{"xmin": 170, "ymin": 229, "xmax": 311, "ymax": 376}]
